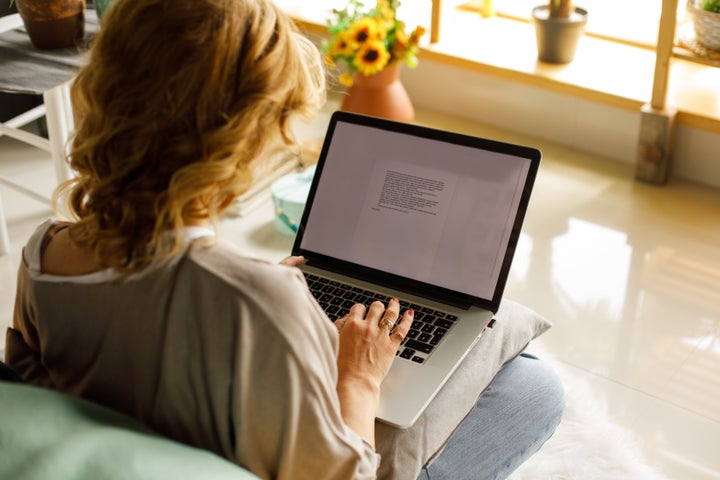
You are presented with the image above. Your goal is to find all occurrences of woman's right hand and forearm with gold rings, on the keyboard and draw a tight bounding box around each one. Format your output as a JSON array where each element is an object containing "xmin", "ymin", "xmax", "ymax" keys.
[{"xmin": 335, "ymin": 298, "xmax": 414, "ymax": 445}]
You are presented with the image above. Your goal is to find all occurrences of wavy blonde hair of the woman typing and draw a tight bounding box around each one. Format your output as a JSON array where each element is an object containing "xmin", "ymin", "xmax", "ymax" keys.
[{"xmin": 55, "ymin": 0, "xmax": 325, "ymax": 273}]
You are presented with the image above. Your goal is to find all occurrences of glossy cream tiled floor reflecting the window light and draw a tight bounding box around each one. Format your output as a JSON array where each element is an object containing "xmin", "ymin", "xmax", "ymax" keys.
[{"xmin": 0, "ymin": 102, "xmax": 720, "ymax": 480}]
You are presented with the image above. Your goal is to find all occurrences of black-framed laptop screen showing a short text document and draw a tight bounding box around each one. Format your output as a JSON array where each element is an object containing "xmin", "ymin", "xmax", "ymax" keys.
[{"xmin": 294, "ymin": 112, "xmax": 540, "ymax": 306}]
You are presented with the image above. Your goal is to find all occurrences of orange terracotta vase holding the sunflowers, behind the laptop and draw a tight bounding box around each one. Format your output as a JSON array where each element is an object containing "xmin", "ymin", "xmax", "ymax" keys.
[{"xmin": 340, "ymin": 63, "xmax": 415, "ymax": 123}]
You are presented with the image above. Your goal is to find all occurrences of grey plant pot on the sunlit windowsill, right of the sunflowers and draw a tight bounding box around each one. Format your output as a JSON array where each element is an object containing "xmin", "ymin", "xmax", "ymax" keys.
[{"xmin": 532, "ymin": 5, "xmax": 588, "ymax": 63}]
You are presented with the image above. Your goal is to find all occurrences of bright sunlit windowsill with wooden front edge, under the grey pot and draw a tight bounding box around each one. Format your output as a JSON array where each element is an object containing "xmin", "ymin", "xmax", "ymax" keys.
[{"xmin": 279, "ymin": 0, "xmax": 720, "ymax": 133}]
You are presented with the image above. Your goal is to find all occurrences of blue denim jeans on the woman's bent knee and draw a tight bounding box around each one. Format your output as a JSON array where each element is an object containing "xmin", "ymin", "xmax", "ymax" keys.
[{"xmin": 418, "ymin": 354, "xmax": 565, "ymax": 480}]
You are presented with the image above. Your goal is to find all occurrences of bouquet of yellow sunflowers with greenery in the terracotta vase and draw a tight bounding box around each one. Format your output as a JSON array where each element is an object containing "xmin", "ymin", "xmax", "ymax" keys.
[{"xmin": 323, "ymin": 0, "xmax": 425, "ymax": 86}]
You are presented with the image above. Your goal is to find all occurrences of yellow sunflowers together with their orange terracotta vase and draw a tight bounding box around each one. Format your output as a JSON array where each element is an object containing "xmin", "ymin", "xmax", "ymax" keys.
[{"xmin": 322, "ymin": 0, "xmax": 425, "ymax": 122}]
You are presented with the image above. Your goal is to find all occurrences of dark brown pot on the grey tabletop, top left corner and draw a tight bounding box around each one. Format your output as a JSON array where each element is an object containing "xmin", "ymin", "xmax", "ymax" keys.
[{"xmin": 15, "ymin": 0, "xmax": 85, "ymax": 50}]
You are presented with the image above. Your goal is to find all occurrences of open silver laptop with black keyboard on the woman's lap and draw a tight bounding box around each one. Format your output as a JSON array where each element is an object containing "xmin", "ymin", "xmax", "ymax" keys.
[{"xmin": 292, "ymin": 111, "xmax": 542, "ymax": 428}]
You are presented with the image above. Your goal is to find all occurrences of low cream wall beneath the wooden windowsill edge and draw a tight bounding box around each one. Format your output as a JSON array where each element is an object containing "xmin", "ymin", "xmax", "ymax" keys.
[{"xmin": 402, "ymin": 61, "xmax": 720, "ymax": 188}]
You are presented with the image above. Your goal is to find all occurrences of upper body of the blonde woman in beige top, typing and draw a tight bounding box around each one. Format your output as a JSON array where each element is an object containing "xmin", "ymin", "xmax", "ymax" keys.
[{"xmin": 7, "ymin": 0, "xmax": 561, "ymax": 479}]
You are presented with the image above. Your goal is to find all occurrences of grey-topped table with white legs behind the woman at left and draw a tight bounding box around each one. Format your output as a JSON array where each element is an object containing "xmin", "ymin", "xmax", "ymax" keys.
[{"xmin": 0, "ymin": 9, "xmax": 99, "ymax": 255}]
